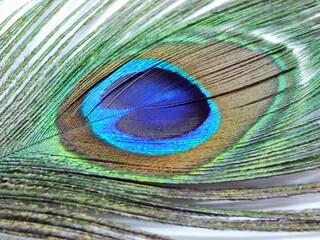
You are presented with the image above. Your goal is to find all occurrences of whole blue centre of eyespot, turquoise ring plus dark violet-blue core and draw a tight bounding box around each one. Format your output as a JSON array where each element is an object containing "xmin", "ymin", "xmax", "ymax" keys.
[{"xmin": 82, "ymin": 59, "xmax": 220, "ymax": 155}]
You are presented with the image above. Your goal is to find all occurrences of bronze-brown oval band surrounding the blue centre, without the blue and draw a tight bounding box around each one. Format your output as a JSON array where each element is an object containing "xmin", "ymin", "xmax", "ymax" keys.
[{"xmin": 57, "ymin": 41, "xmax": 280, "ymax": 177}]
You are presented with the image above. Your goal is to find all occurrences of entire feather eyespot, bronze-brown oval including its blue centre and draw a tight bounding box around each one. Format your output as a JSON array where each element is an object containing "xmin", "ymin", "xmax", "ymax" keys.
[{"xmin": 57, "ymin": 31, "xmax": 282, "ymax": 178}]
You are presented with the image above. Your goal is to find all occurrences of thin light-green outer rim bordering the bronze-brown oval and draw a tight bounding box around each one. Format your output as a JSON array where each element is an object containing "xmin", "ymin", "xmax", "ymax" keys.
[{"xmin": 53, "ymin": 29, "xmax": 300, "ymax": 183}]
